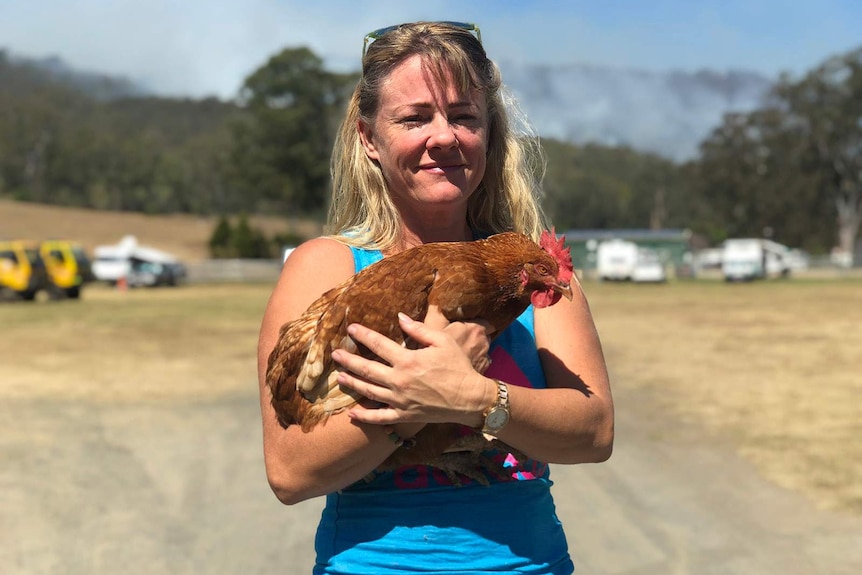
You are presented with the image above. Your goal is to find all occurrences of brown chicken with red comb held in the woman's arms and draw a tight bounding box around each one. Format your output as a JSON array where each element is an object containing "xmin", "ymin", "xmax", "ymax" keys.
[{"xmin": 266, "ymin": 230, "xmax": 572, "ymax": 483}]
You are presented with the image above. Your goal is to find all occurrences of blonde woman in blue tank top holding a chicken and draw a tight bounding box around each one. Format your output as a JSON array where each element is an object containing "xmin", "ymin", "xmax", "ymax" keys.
[{"xmin": 258, "ymin": 22, "xmax": 613, "ymax": 574}]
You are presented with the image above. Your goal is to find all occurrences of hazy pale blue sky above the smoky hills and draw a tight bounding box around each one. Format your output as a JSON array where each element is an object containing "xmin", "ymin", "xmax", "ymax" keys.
[{"xmin": 0, "ymin": 0, "xmax": 862, "ymax": 98}]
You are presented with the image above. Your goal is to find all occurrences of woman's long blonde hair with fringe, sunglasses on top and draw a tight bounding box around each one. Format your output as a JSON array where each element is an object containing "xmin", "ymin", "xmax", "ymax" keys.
[{"xmin": 327, "ymin": 22, "xmax": 546, "ymax": 250}]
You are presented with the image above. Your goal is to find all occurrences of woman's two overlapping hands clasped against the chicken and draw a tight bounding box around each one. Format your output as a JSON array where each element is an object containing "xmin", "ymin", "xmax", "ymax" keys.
[{"xmin": 332, "ymin": 314, "xmax": 493, "ymax": 426}]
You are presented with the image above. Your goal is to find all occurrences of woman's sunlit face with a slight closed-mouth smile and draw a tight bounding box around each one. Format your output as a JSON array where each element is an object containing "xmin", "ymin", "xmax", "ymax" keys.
[{"xmin": 359, "ymin": 56, "xmax": 488, "ymax": 213}]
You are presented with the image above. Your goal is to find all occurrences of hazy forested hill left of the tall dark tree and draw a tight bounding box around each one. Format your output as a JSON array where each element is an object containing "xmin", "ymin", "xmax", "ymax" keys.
[{"xmin": 0, "ymin": 48, "xmax": 240, "ymax": 213}]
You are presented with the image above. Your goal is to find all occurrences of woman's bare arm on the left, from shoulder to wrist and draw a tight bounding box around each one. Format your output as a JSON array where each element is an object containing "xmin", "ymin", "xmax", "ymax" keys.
[{"xmin": 258, "ymin": 238, "xmax": 422, "ymax": 504}]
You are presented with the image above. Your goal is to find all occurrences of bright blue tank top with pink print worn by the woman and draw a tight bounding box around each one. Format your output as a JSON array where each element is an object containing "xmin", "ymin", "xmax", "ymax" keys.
[{"xmin": 314, "ymin": 248, "xmax": 574, "ymax": 575}]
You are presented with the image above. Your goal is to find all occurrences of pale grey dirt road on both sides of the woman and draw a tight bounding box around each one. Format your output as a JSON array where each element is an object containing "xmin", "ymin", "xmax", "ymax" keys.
[{"xmin": 0, "ymin": 385, "xmax": 862, "ymax": 575}]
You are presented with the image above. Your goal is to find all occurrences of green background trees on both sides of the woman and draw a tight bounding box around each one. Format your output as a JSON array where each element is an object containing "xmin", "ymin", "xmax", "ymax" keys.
[{"xmin": 0, "ymin": 48, "xmax": 862, "ymax": 253}]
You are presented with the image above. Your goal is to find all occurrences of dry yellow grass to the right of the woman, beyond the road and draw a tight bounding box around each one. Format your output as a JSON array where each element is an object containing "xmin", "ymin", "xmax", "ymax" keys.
[{"xmin": 587, "ymin": 280, "xmax": 862, "ymax": 514}]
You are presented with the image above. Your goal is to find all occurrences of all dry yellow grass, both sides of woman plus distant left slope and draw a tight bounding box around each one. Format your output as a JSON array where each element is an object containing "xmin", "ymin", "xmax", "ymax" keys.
[{"xmin": 0, "ymin": 201, "xmax": 862, "ymax": 515}]
